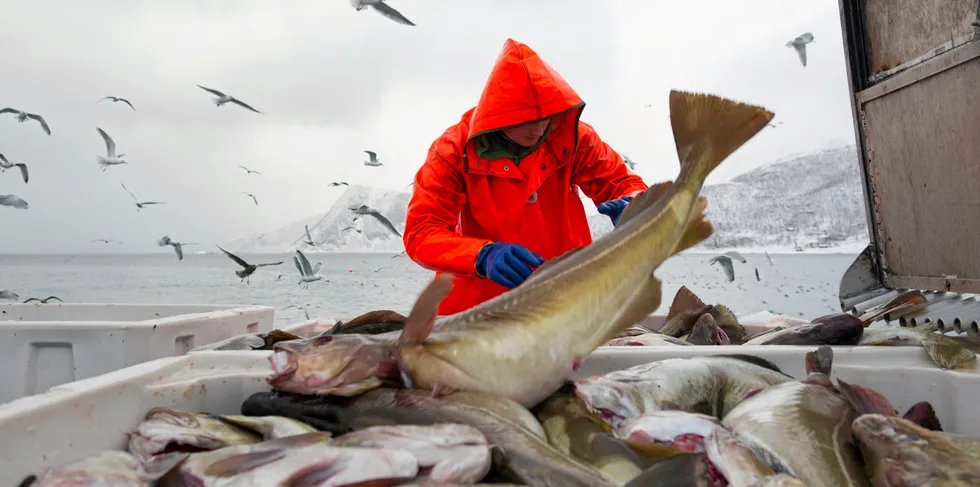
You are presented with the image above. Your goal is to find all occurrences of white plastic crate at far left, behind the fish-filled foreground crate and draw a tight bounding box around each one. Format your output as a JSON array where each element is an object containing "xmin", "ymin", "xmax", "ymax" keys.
[{"xmin": 0, "ymin": 303, "xmax": 275, "ymax": 403}]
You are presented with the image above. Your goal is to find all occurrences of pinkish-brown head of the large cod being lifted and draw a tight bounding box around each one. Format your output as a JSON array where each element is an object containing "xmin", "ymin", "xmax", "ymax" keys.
[{"xmin": 268, "ymin": 335, "xmax": 394, "ymax": 397}]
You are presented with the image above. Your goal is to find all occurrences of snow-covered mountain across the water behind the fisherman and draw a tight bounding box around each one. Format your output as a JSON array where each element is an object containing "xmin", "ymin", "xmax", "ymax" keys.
[{"xmin": 234, "ymin": 145, "xmax": 867, "ymax": 252}]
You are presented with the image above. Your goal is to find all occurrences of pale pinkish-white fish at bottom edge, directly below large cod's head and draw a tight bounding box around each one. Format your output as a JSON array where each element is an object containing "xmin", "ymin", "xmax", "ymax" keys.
[{"xmin": 331, "ymin": 423, "xmax": 490, "ymax": 484}]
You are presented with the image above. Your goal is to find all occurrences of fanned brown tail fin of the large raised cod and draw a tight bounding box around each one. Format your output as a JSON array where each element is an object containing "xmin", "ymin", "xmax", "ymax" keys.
[{"xmin": 670, "ymin": 90, "xmax": 775, "ymax": 184}]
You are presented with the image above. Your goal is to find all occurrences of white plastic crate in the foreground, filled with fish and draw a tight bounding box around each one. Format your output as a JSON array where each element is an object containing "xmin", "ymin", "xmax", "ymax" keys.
[{"xmin": 0, "ymin": 345, "xmax": 980, "ymax": 481}]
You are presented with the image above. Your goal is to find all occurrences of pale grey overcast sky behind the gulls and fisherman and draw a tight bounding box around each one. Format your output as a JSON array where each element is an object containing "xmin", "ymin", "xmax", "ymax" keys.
[{"xmin": 0, "ymin": 0, "xmax": 853, "ymax": 253}]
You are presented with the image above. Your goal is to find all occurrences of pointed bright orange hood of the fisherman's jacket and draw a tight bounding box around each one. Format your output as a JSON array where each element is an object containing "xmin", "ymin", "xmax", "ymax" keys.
[{"xmin": 467, "ymin": 39, "xmax": 585, "ymax": 140}]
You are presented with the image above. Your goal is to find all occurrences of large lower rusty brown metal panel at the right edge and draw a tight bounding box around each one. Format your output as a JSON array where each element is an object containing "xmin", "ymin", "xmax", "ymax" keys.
[{"xmin": 857, "ymin": 47, "xmax": 980, "ymax": 292}]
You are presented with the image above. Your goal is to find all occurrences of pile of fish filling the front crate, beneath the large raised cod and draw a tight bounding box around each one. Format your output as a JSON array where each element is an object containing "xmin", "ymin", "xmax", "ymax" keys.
[{"xmin": 21, "ymin": 346, "xmax": 980, "ymax": 487}]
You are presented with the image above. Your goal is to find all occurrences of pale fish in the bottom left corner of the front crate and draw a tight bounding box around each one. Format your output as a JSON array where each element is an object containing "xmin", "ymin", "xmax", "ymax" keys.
[{"xmin": 29, "ymin": 450, "xmax": 150, "ymax": 487}]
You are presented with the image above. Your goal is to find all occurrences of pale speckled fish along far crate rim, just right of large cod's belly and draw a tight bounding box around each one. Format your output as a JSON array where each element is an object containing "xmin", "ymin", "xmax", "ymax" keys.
[{"xmin": 575, "ymin": 356, "xmax": 793, "ymax": 428}]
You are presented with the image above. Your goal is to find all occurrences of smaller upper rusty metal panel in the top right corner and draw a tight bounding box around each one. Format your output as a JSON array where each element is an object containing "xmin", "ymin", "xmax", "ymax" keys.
[{"xmin": 864, "ymin": 0, "xmax": 977, "ymax": 75}]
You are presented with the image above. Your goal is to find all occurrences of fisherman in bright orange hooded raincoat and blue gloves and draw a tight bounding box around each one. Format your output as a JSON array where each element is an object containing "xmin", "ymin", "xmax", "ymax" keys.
[{"xmin": 403, "ymin": 39, "xmax": 647, "ymax": 315}]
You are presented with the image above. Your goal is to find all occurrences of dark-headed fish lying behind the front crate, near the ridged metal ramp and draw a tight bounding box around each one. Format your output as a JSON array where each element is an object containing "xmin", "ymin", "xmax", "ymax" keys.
[{"xmin": 743, "ymin": 313, "xmax": 865, "ymax": 346}]
